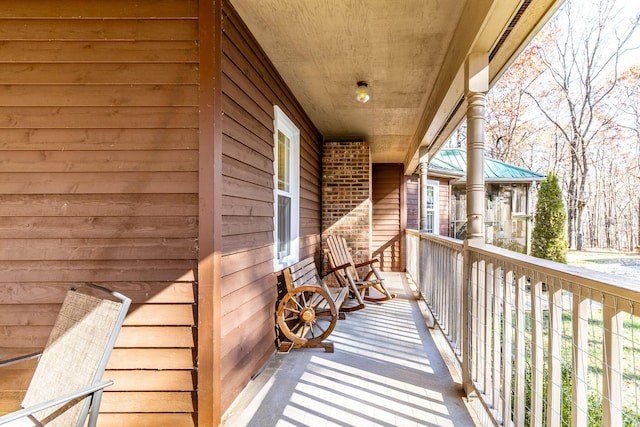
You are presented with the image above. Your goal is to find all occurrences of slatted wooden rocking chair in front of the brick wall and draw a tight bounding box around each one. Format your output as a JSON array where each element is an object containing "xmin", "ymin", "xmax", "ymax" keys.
[{"xmin": 326, "ymin": 236, "xmax": 396, "ymax": 305}]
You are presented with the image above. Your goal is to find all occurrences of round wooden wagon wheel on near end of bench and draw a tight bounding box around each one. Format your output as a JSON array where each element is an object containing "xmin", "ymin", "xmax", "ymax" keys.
[{"xmin": 278, "ymin": 286, "xmax": 338, "ymax": 347}]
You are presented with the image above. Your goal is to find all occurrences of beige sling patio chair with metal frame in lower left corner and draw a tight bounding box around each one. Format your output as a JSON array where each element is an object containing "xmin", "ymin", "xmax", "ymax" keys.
[{"xmin": 0, "ymin": 284, "xmax": 131, "ymax": 427}]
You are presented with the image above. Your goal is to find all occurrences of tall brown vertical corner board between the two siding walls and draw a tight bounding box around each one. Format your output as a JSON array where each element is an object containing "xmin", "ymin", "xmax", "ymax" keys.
[{"xmin": 196, "ymin": 0, "xmax": 222, "ymax": 426}]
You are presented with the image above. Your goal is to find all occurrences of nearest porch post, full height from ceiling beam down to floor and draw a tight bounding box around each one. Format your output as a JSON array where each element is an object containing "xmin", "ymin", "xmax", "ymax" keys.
[{"xmin": 461, "ymin": 52, "xmax": 489, "ymax": 398}]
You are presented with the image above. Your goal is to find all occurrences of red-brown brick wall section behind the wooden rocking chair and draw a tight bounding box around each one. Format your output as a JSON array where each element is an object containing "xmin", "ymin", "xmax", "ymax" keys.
[{"xmin": 322, "ymin": 141, "xmax": 371, "ymax": 271}]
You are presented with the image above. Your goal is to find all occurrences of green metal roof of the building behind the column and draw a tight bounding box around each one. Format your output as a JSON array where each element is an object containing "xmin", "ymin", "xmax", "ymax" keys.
[{"xmin": 429, "ymin": 148, "xmax": 545, "ymax": 182}]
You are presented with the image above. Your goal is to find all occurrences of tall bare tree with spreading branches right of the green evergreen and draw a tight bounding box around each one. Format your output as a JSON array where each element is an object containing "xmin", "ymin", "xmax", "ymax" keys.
[{"xmin": 524, "ymin": 0, "xmax": 638, "ymax": 249}]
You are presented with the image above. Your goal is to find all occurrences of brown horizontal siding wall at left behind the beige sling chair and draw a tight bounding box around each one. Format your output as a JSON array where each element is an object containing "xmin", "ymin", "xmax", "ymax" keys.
[{"xmin": 0, "ymin": 0, "xmax": 199, "ymax": 426}]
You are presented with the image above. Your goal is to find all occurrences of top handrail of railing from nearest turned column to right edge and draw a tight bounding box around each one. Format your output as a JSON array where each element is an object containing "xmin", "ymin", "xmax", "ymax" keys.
[{"xmin": 466, "ymin": 241, "xmax": 640, "ymax": 303}]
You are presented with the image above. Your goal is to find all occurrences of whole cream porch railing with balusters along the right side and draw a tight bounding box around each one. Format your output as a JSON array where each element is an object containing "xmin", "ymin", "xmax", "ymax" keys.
[{"xmin": 406, "ymin": 230, "xmax": 640, "ymax": 426}]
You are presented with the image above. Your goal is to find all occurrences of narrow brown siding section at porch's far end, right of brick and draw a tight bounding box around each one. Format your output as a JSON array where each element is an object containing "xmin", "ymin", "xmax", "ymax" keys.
[{"xmin": 371, "ymin": 164, "xmax": 403, "ymax": 271}]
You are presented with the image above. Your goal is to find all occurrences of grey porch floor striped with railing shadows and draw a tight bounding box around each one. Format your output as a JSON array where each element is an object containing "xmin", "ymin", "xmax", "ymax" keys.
[{"xmin": 222, "ymin": 273, "xmax": 478, "ymax": 427}]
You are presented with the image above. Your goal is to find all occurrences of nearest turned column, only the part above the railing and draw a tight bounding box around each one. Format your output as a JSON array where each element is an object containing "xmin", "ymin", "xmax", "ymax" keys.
[{"xmin": 464, "ymin": 52, "xmax": 489, "ymax": 239}]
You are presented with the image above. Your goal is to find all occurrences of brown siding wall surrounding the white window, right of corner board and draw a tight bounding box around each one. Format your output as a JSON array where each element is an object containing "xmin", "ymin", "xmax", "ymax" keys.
[{"xmin": 222, "ymin": 2, "xmax": 321, "ymax": 409}]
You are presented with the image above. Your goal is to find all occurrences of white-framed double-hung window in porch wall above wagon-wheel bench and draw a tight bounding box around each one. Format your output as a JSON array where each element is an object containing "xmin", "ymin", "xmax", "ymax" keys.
[{"xmin": 273, "ymin": 106, "xmax": 300, "ymax": 271}]
